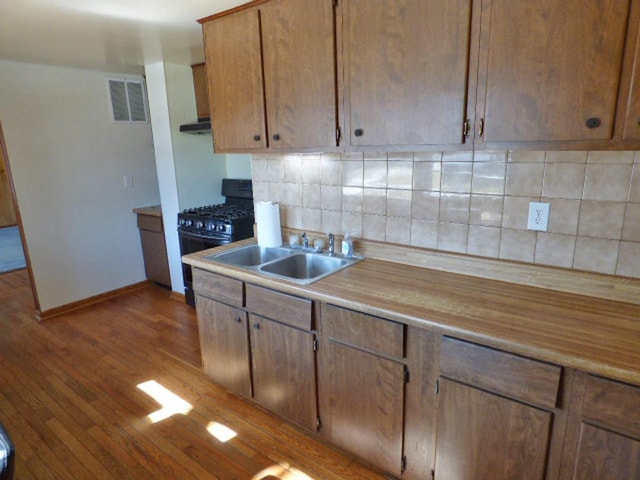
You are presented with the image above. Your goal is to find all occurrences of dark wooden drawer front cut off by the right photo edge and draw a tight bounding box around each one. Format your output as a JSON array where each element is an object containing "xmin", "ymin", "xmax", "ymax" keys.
[{"xmin": 582, "ymin": 376, "xmax": 640, "ymax": 435}]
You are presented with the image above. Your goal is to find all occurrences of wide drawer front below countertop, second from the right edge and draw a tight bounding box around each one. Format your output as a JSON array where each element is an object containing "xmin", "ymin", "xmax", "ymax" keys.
[{"xmin": 440, "ymin": 337, "xmax": 562, "ymax": 408}]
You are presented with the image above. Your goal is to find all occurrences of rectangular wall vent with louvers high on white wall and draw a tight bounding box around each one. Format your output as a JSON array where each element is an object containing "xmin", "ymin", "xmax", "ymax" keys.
[{"xmin": 107, "ymin": 78, "xmax": 147, "ymax": 123}]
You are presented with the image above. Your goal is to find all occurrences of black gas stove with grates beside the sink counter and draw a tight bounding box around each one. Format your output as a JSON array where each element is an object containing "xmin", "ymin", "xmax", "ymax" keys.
[{"xmin": 178, "ymin": 178, "xmax": 255, "ymax": 305}]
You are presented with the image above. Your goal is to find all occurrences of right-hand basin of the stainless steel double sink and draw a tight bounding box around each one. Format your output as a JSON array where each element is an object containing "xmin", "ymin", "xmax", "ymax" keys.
[{"xmin": 259, "ymin": 253, "xmax": 360, "ymax": 284}]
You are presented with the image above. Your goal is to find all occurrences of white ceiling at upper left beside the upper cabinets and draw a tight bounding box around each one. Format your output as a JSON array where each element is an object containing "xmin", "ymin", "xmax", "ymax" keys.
[{"xmin": 0, "ymin": 0, "xmax": 247, "ymax": 74}]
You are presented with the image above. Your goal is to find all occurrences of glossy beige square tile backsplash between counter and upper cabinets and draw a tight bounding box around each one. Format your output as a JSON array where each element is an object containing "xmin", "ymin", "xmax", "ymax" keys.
[{"xmin": 252, "ymin": 151, "xmax": 640, "ymax": 278}]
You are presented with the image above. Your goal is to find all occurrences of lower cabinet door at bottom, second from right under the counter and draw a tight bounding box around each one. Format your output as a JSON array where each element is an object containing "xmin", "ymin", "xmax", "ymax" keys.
[{"xmin": 435, "ymin": 378, "xmax": 552, "ymax": 480}]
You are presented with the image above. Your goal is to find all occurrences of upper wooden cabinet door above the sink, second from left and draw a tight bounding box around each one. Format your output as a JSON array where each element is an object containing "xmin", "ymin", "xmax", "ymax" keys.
[{"xmin": 261, "ymin": 0, "xmax": 337, "ymax": 148}]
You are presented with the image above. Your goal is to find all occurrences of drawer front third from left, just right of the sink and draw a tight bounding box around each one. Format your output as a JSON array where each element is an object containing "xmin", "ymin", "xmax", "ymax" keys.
[{"xmin": 322, "ymin": 304, "xmax": 404, "ymax": 358}]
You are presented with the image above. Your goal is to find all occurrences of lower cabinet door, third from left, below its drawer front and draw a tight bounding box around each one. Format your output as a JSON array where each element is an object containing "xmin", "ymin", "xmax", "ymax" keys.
[{"xmin": 319, "ymin": 342, "xmax": 404, "ymax": 475}]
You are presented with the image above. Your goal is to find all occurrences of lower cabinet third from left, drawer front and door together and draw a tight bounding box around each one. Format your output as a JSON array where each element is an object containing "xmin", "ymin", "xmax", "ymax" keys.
[{"xmin": 318, "ymin": 304, "xmax": 406, "ymax": 476}]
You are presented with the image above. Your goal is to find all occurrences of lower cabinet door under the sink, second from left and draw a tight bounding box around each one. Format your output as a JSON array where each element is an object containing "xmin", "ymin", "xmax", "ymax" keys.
[{"xmin": 250, "ymin": 315, "xmax": 317, "ymax": 430}]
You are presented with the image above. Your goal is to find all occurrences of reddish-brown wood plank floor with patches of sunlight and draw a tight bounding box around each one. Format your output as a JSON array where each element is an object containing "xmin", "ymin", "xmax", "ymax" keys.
[{"xmin": 0, "ymin": 270, "xmax": 385, "ymax": 480}]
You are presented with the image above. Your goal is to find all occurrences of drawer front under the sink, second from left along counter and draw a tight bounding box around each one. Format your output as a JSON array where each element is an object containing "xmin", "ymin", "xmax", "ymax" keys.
[{"xmin": 247, "ymin": 284, "xmax": 313, "ymax": 330}]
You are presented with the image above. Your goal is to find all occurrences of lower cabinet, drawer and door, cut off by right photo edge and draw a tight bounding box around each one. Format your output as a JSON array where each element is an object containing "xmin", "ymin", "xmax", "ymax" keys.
[{"xmin": 561, "ymin": 373, "xmax": 640, "ymax": 480}]
